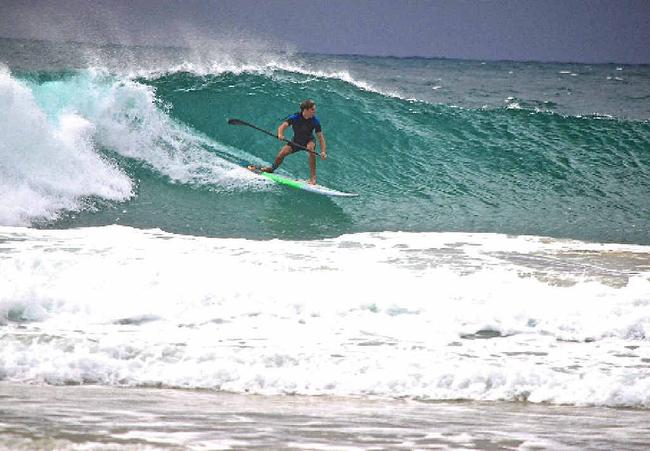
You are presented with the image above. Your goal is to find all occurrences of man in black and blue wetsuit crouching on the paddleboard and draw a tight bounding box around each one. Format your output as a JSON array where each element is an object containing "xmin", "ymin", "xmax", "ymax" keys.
[{"xmin": 260, "ymin": 99, "xmax": 327, "ymax": 185}]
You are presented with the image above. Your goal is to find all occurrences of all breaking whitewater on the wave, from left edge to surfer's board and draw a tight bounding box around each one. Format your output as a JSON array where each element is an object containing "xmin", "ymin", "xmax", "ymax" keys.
[{"xmin": 0, "ymin": 68, "xmax": 261, "ymax": 225}]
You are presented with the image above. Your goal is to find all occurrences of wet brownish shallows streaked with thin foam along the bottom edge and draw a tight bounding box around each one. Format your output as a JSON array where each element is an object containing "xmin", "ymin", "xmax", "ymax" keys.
[{"xmin": 0, "ymin": 383, "xmax": 650, "ymax": 450}]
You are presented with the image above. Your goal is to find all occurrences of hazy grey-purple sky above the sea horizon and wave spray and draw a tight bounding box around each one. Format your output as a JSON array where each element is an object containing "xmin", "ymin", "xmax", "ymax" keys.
[{"xmin": 0, "ymin": 0, "xmax": 650, "ymax": 64}]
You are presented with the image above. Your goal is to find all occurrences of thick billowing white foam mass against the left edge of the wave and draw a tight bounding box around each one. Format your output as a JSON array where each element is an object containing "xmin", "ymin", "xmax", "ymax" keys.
[{"xmin": 0, "ymin": 68, "xmax": 132, "ymax": 225}]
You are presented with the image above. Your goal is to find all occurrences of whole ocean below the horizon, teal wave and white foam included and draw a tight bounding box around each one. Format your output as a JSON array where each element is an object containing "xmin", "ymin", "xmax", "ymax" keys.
[{"xmin": 0, "ymin": 39, "xmax": 650, "ymax": 449}]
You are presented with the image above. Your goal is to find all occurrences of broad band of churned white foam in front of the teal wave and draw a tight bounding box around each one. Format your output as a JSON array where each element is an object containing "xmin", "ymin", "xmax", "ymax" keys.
[{"xmin": 0, "ymin": 226, "xmax": 650, "ymax": 407}]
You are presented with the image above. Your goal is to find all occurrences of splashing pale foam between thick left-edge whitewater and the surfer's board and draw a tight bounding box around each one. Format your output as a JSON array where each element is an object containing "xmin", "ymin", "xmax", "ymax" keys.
[{"xmin": 27, "ymin": 69, "xmax": 260, "ymax": 189}]
